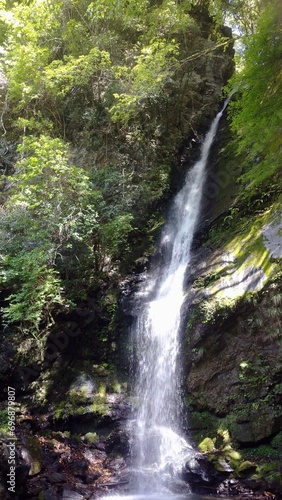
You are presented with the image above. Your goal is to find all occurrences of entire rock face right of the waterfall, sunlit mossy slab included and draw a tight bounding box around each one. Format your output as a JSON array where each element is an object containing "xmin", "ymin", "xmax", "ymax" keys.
[{"xmin": 180, "ymin": 110, "xmax": 282, "ymax": 446}]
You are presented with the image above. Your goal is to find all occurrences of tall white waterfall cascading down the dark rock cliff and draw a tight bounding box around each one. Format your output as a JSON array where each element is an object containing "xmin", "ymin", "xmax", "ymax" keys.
[{"xmin": 131, "ymin": 100, "xmax": 229, "ymax": 493}]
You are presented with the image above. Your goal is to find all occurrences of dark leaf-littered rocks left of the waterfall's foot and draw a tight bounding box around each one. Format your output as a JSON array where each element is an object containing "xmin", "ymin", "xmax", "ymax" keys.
[{"xmin": 0, "ymin": 404, "xmax": 128, "ymax": 500}]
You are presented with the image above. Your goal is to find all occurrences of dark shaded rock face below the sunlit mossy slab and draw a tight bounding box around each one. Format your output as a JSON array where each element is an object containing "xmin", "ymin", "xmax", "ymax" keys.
[{"xmin": 185, "ymin": 258, "xmax": 282, "ymax": 445}]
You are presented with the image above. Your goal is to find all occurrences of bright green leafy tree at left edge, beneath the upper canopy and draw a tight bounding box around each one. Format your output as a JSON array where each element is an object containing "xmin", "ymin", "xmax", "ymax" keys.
[{"xmin": 0, "ymin": 135, "xmax": 90, "ymax": 345}]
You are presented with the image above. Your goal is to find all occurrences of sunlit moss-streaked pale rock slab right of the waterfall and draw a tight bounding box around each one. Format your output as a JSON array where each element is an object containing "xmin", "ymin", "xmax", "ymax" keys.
[{"xmin": 187, "ymin": 203, "xmax": 281, "ymax": 337}]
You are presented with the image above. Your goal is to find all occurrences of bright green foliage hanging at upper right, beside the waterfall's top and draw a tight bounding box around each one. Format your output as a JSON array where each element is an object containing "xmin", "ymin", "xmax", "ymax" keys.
[{"xmin": 228, "ymin": 1, "xmax": 282, "ymax": 187}]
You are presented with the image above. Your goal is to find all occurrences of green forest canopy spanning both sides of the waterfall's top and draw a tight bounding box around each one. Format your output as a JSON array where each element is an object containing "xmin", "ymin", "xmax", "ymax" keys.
[{"xmin": 0, "ymin": 0, "xmax": 282, "ymax": 360}]
